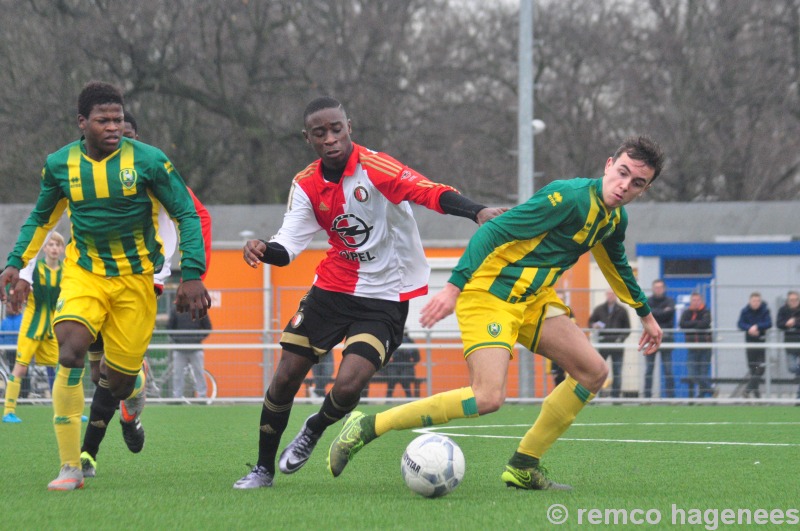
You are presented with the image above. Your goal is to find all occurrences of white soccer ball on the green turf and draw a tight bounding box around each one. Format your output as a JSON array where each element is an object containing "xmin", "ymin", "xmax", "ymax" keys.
[{"xmin": 400, "ymin": 433, "xmax": 465, "ymax": 498}]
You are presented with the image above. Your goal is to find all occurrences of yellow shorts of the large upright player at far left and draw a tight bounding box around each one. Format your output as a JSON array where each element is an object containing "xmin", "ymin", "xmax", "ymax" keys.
[{"xmin": 53, "ymin": 260, "xmax": 156, "ymax": 376}]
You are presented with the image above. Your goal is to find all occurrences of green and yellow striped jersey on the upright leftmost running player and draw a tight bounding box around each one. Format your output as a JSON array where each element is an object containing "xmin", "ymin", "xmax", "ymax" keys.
[{"xmin": 8, "ymin": 138, "xmax": 206, "ymax": 280}]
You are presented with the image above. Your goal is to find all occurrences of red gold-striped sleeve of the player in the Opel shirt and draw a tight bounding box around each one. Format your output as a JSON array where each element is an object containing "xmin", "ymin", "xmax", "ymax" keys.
[{"xmin": 359, "ymin": 148, "xmax": 458, "ymax": 214}]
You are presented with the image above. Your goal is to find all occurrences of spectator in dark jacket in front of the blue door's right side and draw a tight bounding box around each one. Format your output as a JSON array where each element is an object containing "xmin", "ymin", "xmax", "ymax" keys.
[{"xmin": 680, "ymin": 292, "xmax": 714, "ymax": 398}]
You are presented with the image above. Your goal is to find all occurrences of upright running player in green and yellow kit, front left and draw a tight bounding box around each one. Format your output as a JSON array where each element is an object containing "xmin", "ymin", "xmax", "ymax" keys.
[{"xmin": 0, "ymin": 81, "xmax": 211, "ymax": 490}]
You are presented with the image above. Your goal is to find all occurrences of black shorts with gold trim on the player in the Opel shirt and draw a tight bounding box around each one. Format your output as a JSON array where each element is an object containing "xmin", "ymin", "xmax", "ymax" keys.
[{"xmin": 280, "ymin": 286, "xmax": 408, "ymax": 369}]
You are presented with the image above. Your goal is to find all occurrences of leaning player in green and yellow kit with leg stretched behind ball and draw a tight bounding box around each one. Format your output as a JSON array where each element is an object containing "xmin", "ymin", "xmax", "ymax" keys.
[{"xmin": 328, "ymin": 136, "xmax": 664, "ymax": 490}]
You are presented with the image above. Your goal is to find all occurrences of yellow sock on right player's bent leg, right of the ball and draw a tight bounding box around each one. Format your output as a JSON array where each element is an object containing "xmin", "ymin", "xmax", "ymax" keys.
[{"xmin": 517, "ymin": 376, "xmax": 594, "ymax": 459}]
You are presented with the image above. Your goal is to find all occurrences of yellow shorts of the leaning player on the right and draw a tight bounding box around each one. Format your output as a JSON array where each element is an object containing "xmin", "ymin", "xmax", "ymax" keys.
[{"xmin": 456, "ymin": 284, "xmax": 569, "ymax": 358}]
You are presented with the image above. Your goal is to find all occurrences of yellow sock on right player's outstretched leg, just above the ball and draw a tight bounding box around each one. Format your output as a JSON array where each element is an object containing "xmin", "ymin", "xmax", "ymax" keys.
[{"xmin": 375, "ymin": 387, "xmax": 478, "ymax": 436}]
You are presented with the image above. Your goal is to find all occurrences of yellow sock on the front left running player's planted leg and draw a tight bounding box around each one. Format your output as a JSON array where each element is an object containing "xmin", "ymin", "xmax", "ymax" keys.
[{"xmin": 53, "ymin": 365, "xmax": 84, "ymax": 468}]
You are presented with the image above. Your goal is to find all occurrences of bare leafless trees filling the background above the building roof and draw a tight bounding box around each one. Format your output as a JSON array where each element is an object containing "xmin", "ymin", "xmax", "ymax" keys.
[{"xmin": 0, "ymin": 0, "xmax": 800, "ymax": 203}]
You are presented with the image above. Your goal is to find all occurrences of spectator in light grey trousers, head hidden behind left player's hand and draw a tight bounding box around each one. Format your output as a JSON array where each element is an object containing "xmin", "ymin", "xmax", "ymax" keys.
[{"xmin": 167, "ymin": 306, "xmax": 211, "ymax": 398}]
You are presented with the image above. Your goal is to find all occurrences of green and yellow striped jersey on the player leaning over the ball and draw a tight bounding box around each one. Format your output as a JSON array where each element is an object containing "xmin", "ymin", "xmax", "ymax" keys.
[{"xmin": 449, "ymin": 178, "xmax": 650, "ymax": 316}]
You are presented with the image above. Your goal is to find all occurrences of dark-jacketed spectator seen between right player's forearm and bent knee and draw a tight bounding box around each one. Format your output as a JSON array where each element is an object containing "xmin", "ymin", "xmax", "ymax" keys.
[{"xmin": 589, "ymin": 290, "xmax": 632, "ymax": 398}]
